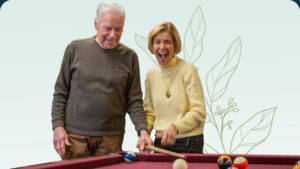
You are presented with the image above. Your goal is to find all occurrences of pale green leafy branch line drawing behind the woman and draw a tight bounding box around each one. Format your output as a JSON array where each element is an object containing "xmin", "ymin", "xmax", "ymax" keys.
[{"xmin": 135, "ymin": 6, "xmax": 277, "ymax": 154}]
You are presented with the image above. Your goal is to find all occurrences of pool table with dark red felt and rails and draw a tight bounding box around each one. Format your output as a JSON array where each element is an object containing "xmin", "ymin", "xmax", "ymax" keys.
[{"xmin": 16, "ymin": 153, "xmax": 300, "ymax": 169}]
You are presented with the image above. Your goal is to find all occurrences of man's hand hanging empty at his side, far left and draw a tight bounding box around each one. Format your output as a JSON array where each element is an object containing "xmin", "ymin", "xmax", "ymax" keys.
[{"xmin": 53, "ymin": 127, "xmax": 71, "ymax": 157}]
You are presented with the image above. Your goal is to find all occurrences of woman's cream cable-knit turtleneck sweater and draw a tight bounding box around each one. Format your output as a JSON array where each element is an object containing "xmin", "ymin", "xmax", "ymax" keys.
[{"xmin": 144, "ymin": 57, "xmax": 206, "ymax": 138}]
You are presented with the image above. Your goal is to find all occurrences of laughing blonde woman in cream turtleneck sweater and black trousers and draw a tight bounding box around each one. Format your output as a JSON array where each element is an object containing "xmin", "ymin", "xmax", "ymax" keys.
[{"xmin": 144, "ymin": 22, "xmax": 206, "ymax": 153}]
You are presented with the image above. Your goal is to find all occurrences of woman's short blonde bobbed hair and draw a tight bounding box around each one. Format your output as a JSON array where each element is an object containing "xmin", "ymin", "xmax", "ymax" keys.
[{"xmin": 148, "ymin": 22, "xmax": 181, "ymax": 54}]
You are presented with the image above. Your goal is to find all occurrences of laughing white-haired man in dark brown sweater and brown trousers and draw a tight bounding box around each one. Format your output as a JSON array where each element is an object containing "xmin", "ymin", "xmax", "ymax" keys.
[{"xmin": 52, "ymin": 3, "xmax": 153, "ymax": 160}]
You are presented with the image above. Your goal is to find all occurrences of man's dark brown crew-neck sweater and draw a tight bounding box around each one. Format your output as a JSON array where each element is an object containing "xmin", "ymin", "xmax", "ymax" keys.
[{"xmin": 52, "ymin": 37, "xmax": 146, "ymax": 136}]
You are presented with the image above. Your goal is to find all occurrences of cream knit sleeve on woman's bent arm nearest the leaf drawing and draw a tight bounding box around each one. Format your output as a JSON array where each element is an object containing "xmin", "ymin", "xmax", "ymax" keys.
[{"xmin": 173, "ymin": 66, "xmax": 206, "ymax": 134}]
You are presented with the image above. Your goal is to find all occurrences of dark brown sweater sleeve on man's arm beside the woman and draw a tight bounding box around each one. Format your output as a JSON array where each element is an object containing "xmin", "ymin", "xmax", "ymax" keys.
[{"xmin": 126, "ymin": 54, "xmax": 146, "ymax": 135}]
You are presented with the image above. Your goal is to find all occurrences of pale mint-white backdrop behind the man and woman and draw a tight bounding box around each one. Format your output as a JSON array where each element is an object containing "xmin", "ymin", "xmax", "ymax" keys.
[{"xmin": 0, "ymin": 0, "xmax": 300, "ymax": 168}]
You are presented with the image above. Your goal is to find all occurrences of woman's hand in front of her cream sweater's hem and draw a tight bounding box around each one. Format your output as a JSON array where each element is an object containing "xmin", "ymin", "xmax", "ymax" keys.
[{"xmin": 156, "ymin": 125, "xmax": 177, "ymax": 146}]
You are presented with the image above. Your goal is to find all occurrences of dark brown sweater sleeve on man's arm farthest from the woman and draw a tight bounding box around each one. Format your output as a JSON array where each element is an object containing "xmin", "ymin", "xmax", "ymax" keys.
[{"xmin": 51, "ymin": 45, "xmax": 73, "ymax": 130}]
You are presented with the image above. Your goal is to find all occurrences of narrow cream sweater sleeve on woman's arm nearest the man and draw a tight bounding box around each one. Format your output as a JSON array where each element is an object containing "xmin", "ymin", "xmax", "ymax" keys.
[{"xmin": 144, "ymin": 74, "xmax": 155, "ymax": 134}]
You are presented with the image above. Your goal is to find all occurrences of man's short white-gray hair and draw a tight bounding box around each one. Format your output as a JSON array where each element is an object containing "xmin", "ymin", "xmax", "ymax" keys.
[{"xmin": 96, "ymin": 2, "xmax": 125, "ymax": 23}]
